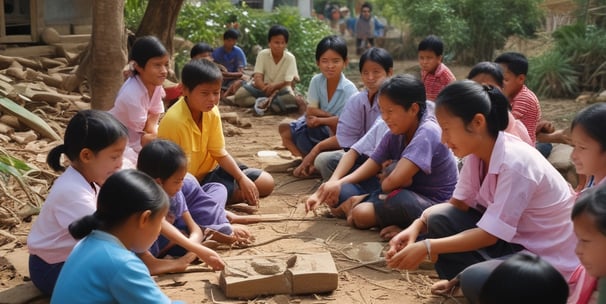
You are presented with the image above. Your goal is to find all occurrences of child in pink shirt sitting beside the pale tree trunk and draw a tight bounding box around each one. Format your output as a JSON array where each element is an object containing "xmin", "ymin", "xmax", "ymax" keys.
[{"xmin": 109, "ymin": 36, "xmax": 169, "ymax": 168}]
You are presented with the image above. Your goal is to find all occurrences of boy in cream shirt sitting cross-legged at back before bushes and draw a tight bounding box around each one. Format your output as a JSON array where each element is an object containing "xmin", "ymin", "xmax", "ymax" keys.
[{"xmin": 234, "ymin": 25, "xmax": 300, "ymax": 113}]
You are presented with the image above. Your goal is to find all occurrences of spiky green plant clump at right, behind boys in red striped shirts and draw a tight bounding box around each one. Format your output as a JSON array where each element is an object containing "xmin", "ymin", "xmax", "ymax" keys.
[{"xmin": 527, "ymin": 49, "xmax": 579, "ymax": 97}]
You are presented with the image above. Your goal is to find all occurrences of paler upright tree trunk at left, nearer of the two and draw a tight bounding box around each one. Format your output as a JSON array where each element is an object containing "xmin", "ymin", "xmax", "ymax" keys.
[{"xmin": 88, "ymin": 0, "xmax": 127, "ymax": 110}]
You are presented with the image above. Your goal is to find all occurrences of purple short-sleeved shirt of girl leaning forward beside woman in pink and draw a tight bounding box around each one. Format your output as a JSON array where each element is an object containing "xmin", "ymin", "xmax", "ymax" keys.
[{"xmin": 370, "ymin": 111, "xmax": 459, "ymax": 201}]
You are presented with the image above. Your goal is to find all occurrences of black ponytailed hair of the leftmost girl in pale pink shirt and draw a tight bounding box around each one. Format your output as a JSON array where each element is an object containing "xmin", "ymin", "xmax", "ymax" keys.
[{"xmin": 46, "ymin": 110, "xmax": 128, "ymax": 171}]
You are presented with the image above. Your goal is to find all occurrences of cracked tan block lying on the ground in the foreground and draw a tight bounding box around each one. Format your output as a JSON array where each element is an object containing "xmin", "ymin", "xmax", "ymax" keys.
[{"xmin": 219, "ymin": 252, "xmax": 339, "ymax": 299}]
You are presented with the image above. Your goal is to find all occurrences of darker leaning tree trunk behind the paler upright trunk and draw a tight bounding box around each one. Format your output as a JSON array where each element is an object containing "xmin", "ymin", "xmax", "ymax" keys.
[{"xmin": 135, "ymin": 0, "xmax": 184, "ymax": 58}]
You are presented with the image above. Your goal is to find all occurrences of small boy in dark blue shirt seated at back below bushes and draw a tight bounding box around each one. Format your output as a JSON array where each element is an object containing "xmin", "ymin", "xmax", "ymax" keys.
[{"xmin": 212, "ymin": 29, "xmax": 248, "ymax": 98}]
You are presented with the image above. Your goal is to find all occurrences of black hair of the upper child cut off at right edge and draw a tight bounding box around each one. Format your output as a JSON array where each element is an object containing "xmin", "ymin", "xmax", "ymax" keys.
[{"xmin": 570, "ymin": 103, "xmax": 606, "ymax": 151}]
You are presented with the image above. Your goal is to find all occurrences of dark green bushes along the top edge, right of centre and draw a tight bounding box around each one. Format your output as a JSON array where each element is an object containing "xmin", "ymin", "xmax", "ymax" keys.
[{"xmin": 381, "ymin": 0, "xmax": 542, "ymax": 64}]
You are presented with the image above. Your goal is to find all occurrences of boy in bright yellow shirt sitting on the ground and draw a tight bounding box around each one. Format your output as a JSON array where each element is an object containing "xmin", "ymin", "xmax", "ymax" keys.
[{"xmin": 158, "ymin": 60, "xmax": 274, "ymax": 205}]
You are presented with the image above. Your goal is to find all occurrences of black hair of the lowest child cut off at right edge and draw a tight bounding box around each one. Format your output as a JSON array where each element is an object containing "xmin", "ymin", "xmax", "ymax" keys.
[{"xmin": 571, "ymin": 184, "xmax": 606, "ymax": 235}]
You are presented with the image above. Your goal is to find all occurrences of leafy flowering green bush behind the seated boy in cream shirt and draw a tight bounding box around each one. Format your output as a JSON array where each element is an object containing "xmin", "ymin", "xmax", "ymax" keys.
[{"xmin": 176, "ymin": 0, "xmax": 331, "ymax": 92}]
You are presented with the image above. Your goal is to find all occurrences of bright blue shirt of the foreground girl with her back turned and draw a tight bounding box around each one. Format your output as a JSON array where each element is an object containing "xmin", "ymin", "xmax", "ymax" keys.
[{"xmin": 51, "ymin": 230, "xmax": 178, "ymax": 304}]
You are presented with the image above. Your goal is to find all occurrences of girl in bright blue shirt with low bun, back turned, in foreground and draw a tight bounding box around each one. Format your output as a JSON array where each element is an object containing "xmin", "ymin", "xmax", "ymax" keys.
[{"xmin": 51, "ymin": 169, "xmax": 190, "ymax": 303}]
